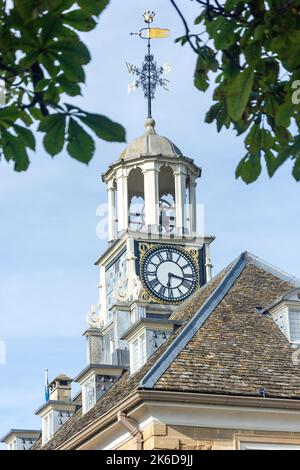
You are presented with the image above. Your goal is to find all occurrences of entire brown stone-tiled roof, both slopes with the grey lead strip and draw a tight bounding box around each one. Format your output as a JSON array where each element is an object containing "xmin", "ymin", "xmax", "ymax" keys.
[{"xmin": 32, "ymin": 253, "xmax": 300, "ymax": 450}]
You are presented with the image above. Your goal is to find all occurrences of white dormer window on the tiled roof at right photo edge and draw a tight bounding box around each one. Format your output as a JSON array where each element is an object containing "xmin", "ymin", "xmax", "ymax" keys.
[{"xmin": 263, "ymin": 288, "xmax": 300, "ymax": 344}]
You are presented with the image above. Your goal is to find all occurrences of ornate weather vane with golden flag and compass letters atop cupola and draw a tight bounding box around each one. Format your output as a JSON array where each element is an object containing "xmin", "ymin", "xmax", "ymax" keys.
[{"xmin": 126, "ymin": 11, "xmax": 171, "ymax": 118}]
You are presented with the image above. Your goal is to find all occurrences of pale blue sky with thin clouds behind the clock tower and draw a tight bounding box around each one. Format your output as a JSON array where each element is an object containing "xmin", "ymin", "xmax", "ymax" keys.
[{"xmin": 0, "ymin": 0, "xmax": 300, "ymax": 448}]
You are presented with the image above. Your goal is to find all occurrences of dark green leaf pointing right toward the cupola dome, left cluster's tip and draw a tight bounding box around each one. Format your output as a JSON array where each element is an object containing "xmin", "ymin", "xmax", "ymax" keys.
[{"xmin": 79, "ymin": 113, "xmax": 126, "ymax": 142}]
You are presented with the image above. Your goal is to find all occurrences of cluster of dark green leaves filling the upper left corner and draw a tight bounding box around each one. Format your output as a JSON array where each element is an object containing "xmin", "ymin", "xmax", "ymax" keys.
[{"xmin": 0, "ymin": 0, "xmax": 125, "ymax": 171}]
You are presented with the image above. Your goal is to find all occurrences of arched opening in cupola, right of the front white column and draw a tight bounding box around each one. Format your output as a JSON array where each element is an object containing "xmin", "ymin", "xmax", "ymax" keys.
[{"xmin": 158, "ymin": 165, "xmax": 175, "ymax": 233}]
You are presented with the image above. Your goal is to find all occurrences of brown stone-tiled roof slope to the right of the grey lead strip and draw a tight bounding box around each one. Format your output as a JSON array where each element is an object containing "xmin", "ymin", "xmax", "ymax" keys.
[{"xmin": 155, "ymin": 263, "xmax": 300, "ymax": 398}]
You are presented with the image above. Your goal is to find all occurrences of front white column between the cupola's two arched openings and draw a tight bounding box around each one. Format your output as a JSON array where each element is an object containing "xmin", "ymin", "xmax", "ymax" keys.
[{"xmin": 143, "ymin": 162, "xmax": 159, "ymax": 230}]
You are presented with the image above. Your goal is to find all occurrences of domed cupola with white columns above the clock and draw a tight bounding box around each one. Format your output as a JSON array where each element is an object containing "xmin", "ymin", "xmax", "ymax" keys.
[{"xmin": 102, "ymin": 118, "xmax": 201, "ymax": 242}]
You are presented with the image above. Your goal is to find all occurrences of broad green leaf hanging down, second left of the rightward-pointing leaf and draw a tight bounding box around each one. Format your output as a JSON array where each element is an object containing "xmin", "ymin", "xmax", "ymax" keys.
[{"xmin": 39, "ymin": 113, "xmax": 66, "ymax": 156}]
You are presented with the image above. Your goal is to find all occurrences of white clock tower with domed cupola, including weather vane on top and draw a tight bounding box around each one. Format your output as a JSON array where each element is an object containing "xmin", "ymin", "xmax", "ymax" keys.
[{"xmin": 84, "ymin": 12, "xmax": 213, "ymax": 380}]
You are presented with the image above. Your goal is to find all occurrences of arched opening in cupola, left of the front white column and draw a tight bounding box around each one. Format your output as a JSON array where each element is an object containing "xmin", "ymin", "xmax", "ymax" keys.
[{"xmin": 128, "ymin": 168, "xmax": 145, "ymax": 232}]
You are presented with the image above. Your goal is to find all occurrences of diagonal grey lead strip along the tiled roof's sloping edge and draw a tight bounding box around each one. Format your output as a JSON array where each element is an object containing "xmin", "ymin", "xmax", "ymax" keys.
[{"xmin": 139, "ymin": 252, "xmax": 249, "ymax": 388}]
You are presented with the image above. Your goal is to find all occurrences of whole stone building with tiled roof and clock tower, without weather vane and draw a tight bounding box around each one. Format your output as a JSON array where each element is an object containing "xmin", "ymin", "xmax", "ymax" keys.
[{"xmin": 3, "ymin": 119, "xmax": 300, "ymax": 450}]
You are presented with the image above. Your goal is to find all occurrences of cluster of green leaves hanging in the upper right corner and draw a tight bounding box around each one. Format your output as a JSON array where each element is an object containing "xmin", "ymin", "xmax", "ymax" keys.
[{"xmin": 176, "ymin": 0, "xmax": 300, "ymax": 183}]
